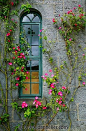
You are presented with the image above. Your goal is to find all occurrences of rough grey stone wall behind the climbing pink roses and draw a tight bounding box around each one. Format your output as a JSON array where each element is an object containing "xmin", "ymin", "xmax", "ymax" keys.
[{"xmin": 0, "ymin": 0, "xmax": 86, "ymax": 131}]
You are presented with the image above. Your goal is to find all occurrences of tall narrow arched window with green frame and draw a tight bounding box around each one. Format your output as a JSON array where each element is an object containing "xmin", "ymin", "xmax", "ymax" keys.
[{"xmin": 19, "ymin": 11, "xmax": 42, "ymax": 98}]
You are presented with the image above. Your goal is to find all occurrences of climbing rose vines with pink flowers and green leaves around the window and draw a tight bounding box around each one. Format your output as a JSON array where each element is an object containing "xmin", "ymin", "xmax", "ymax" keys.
[{"xmin": 0, "ymin": 0, "xmax": 86, "ymax": 131}]
